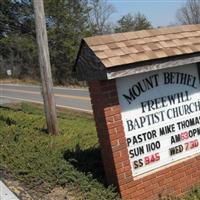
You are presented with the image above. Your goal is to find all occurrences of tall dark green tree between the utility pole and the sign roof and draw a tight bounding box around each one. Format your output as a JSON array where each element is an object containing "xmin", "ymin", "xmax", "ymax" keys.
[{"xmin": 45, "ymin": 0, "xmax": 91, "ymax": 84}]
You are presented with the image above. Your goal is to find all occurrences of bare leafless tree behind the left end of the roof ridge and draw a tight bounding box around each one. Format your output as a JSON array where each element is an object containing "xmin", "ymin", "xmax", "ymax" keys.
[{"xmin": 89, "ymin": 0, "xmax": 115, "ymax": 35}]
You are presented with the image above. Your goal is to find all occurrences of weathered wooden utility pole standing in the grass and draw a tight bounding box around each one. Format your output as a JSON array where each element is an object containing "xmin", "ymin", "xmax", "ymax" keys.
[{"xmin": 33, "ymin": 0, "xmax": 58, "ymax": 135}]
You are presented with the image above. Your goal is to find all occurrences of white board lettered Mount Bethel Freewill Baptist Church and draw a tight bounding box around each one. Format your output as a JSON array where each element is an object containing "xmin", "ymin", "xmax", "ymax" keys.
[{"xmin": 117, "ymin": 64, "xmax": 200, "ymax": 176}]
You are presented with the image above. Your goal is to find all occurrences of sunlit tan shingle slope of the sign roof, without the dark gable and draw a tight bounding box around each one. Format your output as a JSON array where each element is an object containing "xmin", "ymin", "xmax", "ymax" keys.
[{"xmin": 84, "ymin": 24, "xmax": 200, "ymax": 68}]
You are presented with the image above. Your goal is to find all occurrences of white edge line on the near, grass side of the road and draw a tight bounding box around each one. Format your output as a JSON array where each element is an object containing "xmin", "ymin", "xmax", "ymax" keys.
[{"xmin": 0, "ymin": 96, "xmax": 92, "ymax": 114}]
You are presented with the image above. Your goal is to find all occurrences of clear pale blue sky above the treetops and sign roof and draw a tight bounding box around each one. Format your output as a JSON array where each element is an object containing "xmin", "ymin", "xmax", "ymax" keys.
[{"xmin": 107, "ymin": 0, "xmax": 186, "ymax": 27}]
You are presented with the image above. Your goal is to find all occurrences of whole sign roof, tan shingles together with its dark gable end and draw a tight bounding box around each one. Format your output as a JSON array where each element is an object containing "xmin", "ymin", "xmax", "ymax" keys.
[{"xmin": 75, "ymin": 24, "xmax": 200, "ymax": 79}]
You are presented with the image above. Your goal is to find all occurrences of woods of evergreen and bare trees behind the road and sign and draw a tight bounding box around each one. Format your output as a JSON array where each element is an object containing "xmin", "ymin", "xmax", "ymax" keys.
[{"xmin": 0, "ymin": 0, "xmax": 200, "ymax": 85}]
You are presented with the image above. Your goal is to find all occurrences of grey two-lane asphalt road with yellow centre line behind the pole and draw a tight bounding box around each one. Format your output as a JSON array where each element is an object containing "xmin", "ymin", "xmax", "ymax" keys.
[{"xmin": 0, "ymin": 84, "xmax": 92, "ymax": 113}]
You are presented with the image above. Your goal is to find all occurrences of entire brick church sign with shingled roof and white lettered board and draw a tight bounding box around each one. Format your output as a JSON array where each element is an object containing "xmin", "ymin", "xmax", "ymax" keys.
[{"xmin": 74, "ymin": 25, "xmax": 200, "ymax": 200}]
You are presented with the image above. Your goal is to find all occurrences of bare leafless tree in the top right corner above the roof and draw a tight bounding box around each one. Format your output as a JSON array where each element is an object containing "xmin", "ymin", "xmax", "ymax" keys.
[{"xmin": 176, "ymin": 0, "xmax": 200, "ymax": 24}]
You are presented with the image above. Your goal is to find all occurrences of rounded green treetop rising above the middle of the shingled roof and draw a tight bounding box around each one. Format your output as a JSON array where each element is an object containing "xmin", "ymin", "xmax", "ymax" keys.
[{"xmin": 115, "ymin": 13, "xmax": 152, "ymax": 32}]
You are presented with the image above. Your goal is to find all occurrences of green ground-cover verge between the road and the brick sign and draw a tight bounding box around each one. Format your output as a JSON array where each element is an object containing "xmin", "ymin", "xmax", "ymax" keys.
[{"xmin": 0, "ymin": 104, "xmax": 119, "ymax": 200}]
